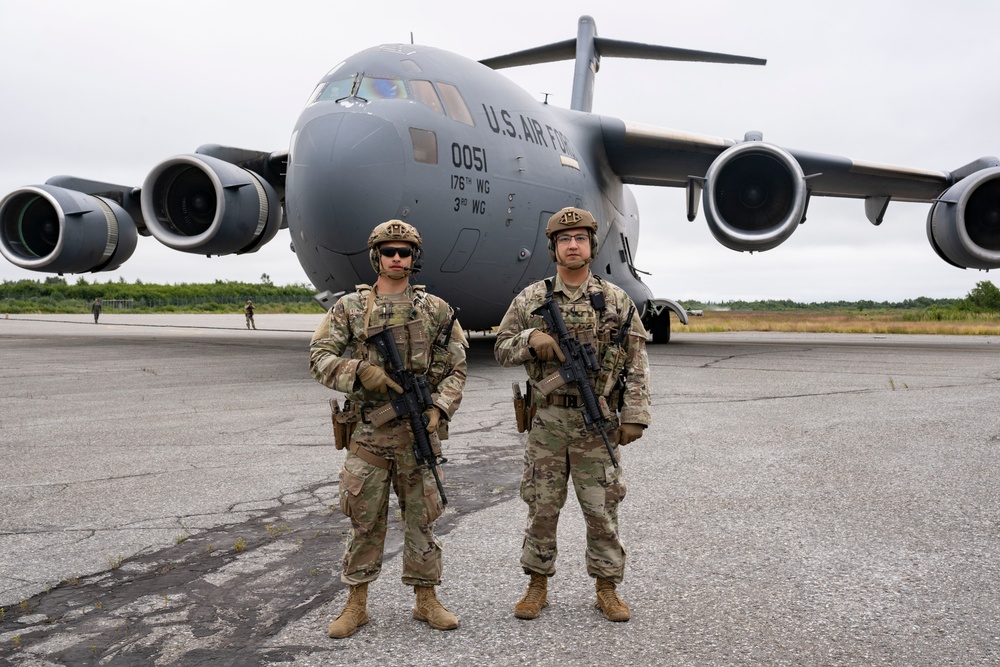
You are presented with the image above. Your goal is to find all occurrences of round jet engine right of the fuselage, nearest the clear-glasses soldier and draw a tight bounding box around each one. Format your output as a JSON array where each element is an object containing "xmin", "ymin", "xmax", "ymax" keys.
[{"xmin": 703, "ymin": 141, "xmax": 808, "ymax": 252}]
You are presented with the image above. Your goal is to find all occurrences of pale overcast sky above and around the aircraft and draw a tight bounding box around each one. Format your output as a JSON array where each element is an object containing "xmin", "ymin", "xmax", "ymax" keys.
[{"xmin": 0, "ymin": 0, "xmax": 1000, "ymax": 301}]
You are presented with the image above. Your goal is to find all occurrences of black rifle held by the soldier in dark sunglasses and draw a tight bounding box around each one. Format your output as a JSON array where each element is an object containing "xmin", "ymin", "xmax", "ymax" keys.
[{"xmin": 368, "ymin": 329, "xmax": 448, "ymax": 505}]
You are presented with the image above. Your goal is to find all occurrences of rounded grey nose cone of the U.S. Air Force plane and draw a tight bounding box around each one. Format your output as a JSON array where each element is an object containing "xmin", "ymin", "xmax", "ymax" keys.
[{"xmin": 286, "ymin": 111, "xmax": 404, "ymax": 254}]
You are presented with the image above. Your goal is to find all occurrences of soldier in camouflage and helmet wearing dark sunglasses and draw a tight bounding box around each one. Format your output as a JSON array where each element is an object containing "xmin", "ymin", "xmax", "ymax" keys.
[{"xmin": 309, "ymin": 220, "xmax": 468, "ymax": 638}]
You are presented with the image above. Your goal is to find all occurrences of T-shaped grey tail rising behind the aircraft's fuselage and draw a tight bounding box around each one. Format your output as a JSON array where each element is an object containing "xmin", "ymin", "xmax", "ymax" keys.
[{"xmin": 479, "ymin": 16, "xmax": 767, "ymax": 113}]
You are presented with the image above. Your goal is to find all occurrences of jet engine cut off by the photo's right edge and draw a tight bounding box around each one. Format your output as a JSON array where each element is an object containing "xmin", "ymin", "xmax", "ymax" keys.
[{"xmin": 927, "ymin": 167, "xmax": 1000, "ymax": 269}]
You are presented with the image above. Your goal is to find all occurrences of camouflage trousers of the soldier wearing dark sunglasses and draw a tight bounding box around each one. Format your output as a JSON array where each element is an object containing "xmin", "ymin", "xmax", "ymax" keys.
[{"xmin": 340, "ymin": 419, "xmax": 444, "ymax": 586}]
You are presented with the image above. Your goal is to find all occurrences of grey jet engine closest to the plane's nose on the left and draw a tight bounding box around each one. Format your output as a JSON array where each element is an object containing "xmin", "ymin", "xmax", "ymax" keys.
[{"xmin": 141, "ymin": 155, "xmax": 281, "ymax": 255}]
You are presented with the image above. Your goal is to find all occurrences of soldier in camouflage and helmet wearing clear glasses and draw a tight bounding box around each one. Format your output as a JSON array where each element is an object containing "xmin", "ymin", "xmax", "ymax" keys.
[{"xmin": 494, "ymin": 207, "xmax": 649, "ymax": 621}]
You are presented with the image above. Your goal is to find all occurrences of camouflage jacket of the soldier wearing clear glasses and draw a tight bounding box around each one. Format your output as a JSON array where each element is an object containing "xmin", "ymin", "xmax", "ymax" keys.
[{"xmin": 493, "ymin": 274, "xmax": 649, "ymax": 426}]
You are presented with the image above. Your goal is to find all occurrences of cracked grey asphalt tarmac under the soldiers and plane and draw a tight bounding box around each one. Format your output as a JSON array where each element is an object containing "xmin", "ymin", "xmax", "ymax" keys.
[{"xmin": 0, "ymin": 312, "xmax": 1000, "ymax": 667}]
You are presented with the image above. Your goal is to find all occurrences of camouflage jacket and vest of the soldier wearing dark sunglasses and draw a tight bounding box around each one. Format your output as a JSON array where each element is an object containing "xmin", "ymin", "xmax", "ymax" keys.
[{"xmin": 309, "ymin": 285, "xmax": 469, "ymax": 419}]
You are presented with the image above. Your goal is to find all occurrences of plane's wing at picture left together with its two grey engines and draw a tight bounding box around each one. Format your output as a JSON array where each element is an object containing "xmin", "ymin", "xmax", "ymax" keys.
[{"xmin": 0, "ymin": 144, "xmax": 288, "ymax": 273}]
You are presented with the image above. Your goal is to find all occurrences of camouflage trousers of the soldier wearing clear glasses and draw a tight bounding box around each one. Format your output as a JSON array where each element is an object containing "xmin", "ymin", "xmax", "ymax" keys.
[{"xmin": 521, "ymin": 406, "xmax": 626, "ymax": 583}]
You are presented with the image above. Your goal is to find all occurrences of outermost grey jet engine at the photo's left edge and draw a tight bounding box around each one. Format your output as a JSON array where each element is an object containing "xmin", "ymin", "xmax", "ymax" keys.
[{"xmin": 0, "ymin": 185, "xmax": 138, "ymax": 273}]
